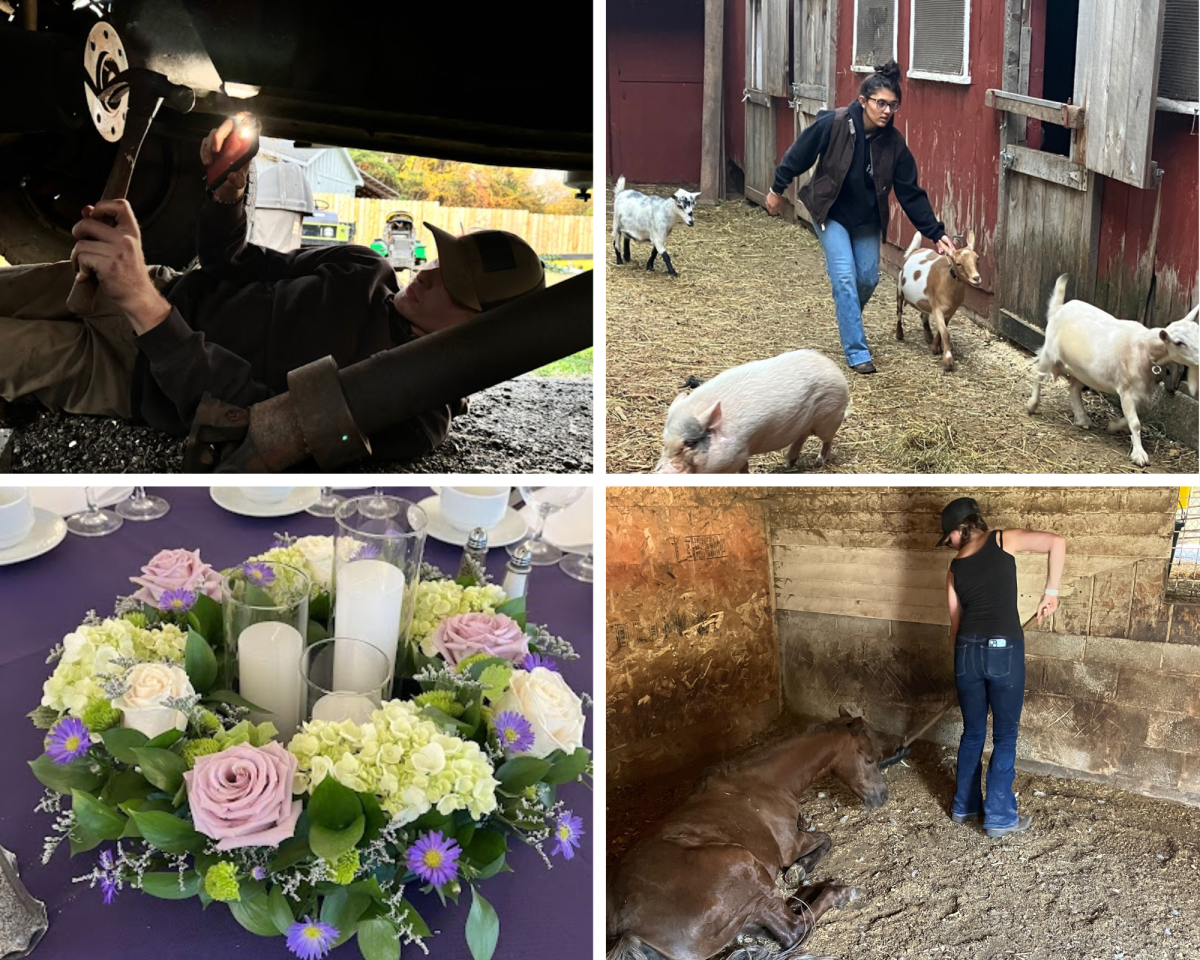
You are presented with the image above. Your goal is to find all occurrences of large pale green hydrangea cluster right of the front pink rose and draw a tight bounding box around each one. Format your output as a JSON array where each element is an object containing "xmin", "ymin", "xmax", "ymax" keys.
[{"xmin": 288, "ymin": 700, "xmax": 497, "ymax": 823}]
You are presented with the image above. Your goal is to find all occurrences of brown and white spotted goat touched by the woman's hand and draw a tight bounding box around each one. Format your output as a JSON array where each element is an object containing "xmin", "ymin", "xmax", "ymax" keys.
[{"xmin": 896, "ymin": 230, "xmax": 983, "ymax": 370}]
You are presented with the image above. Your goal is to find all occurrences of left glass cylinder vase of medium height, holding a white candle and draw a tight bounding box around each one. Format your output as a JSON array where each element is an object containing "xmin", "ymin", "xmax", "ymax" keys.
[{"xmin": 223, "ymin": 560, "xmax": 312, "ymax": 744}]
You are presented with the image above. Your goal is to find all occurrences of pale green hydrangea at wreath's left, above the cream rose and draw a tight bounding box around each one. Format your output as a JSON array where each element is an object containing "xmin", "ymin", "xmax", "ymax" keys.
[{"xmin": 42, "ymin": 617, "xmax": 187, "ymax": 716}]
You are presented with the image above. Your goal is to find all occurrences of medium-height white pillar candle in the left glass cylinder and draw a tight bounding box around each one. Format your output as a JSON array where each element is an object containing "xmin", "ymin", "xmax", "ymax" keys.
[{"xmin": 238, "ymin": 620, "xmax": 304, "ymax": 743}]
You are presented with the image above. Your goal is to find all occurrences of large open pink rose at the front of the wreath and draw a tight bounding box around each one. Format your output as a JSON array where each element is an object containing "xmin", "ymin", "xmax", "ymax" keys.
[{"xmin": 184, "ymin": 740, "xmax": 302, "ymax": 850}]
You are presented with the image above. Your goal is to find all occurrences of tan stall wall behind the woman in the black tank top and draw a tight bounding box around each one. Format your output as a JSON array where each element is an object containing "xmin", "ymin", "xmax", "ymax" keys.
[{"xmin": 768, "ymin": 487, "xmax": 1200, "ymax": 804}]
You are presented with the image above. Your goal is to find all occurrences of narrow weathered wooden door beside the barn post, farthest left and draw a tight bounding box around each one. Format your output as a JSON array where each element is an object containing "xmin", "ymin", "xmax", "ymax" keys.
[{"xmin": 743, "ymin": 0, "xmax": 790, "ymax": 204}]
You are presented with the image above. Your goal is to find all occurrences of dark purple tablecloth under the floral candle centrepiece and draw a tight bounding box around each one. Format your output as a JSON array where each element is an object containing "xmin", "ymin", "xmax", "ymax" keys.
[{"xmin": 0, "ymin": 487, "xmax": 594, "ymax": 960}]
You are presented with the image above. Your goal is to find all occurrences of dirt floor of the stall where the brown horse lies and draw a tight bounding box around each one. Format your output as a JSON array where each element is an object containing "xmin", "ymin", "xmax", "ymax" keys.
[{"xmin": 607, "ymin": 714, "xmax": 1200, "ymax": 960}]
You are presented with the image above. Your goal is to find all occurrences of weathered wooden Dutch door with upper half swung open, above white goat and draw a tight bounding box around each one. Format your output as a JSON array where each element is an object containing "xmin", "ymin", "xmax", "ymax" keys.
[{"xmin": 986, "ymin": 0, "xmax": 1164, "ymax": 349}]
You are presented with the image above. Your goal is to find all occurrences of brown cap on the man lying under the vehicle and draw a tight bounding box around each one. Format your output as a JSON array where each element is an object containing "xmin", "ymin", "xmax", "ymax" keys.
[{"xmin": 425, "ymin": 223, "xmax": 546, "ymax": 310}]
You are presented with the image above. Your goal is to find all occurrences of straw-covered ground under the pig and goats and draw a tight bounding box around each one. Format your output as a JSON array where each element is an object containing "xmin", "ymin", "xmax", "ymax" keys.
[{"xmin": 605, "ymin": 185, "xmax": 1198, "ymax": 474}]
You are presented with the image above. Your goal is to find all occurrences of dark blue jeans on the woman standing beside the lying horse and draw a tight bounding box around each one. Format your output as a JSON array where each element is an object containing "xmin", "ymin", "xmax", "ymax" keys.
[{"xmin": 952, "ymin": 634, "xmax": 1025, "ymax": 829}]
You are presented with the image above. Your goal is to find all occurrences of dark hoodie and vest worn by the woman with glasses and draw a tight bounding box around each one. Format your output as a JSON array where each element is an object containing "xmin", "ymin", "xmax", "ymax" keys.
[{"xmin": 772, "ymin": 100, "xmax": 946, "ymax": 244}]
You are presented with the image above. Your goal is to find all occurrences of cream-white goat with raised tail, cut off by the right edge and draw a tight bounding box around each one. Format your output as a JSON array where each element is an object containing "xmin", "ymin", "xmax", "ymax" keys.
[{"xmin": 1026, "ymin": 274, "xmax": 1200, "ymax": 467}]
